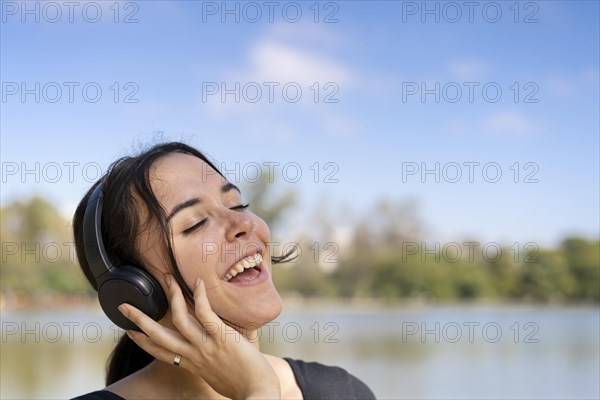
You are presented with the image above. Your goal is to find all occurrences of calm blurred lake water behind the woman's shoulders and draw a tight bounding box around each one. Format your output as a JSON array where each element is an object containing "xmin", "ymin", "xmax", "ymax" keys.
[{"xmin": 0, "ymin": 305, "xmax": 600, "ymax": 399}]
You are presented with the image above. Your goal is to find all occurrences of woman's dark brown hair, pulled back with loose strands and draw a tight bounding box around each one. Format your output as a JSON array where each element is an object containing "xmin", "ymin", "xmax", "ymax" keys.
[{"xmin": 73, "ymin": 142, "xmax": 293, "ymax": 385}]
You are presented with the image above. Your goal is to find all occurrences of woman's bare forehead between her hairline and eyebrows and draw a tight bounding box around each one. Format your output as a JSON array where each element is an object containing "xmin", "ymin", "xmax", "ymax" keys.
[{"xmin": 150, "ymin": 153, "xmax": 227, "ymax": 204}]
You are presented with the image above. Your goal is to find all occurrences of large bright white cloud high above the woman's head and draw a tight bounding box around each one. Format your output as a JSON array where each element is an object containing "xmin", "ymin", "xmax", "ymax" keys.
[{"xmin": 203, "ymin": 25, "xmax": 359, "ymax": 141}]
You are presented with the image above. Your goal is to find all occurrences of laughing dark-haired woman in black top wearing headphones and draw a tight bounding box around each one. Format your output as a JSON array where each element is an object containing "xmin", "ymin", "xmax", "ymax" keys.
[{"xmin": 73, "ymin": 143, "xmax": 374, "ymax": 400}]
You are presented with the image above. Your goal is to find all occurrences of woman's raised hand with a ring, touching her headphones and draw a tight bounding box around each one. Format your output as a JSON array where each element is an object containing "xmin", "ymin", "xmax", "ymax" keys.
[{"xmin": 119, "ymin": 275, "xmax": 281, "ymax": 399}]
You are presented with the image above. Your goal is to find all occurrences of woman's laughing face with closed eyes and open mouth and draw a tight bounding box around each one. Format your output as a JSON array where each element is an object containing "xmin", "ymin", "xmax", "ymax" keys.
[{"xmin": 138, "ymin": 154, "xmax": 281, "ymax": 328}]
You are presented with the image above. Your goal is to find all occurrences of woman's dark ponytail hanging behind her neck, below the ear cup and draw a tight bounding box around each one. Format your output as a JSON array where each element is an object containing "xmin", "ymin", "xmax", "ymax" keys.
[{"xmin": 106, "ymin": 335, "xmax": 154, "ymax": 386}]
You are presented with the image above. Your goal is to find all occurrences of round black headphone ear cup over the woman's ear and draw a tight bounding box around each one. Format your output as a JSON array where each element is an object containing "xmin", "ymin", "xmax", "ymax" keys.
[{"xmin": 98, "ymin": 265, "xmax": 168, "ymax": 331}]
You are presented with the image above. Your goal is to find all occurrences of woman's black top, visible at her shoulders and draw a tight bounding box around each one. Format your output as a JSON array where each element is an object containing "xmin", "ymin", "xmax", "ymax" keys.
[{"xmin": 73, "ymin": 358, "xmax": 375, "ymax": 400}]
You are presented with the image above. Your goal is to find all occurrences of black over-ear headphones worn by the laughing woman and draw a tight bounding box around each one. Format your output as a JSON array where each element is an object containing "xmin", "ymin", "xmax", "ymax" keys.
[{"xmin": 83, "ymin": 182, "xmax": 168, "ymax": 331}]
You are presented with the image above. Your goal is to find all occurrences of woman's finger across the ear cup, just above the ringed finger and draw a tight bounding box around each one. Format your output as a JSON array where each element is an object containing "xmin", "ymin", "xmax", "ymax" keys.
[{"xmin": 119, "ymin": 304, "xmax": 191, "ymax": 354}]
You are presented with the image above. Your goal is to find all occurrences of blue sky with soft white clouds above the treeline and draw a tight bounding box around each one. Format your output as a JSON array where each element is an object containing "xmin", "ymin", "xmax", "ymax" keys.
[{"xmin": 0, "ymin": 1, "xmax": 600, "ymax": 245}]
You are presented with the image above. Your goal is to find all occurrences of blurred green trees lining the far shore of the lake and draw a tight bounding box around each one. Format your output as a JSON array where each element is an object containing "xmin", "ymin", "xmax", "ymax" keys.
[{"xmin": 0, "ymin": 189, "xmax": 600, "ymax": 303}]
